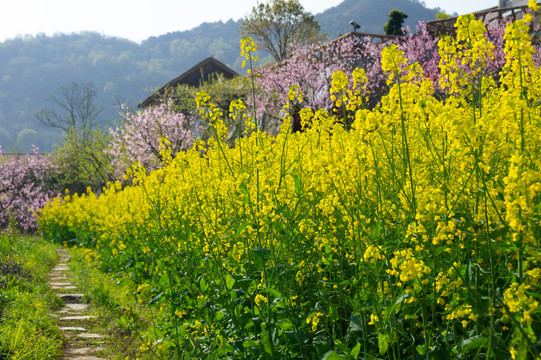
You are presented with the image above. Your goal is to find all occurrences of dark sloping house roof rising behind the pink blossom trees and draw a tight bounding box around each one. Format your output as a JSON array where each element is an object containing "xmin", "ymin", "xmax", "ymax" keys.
[{"xmin": 138, "ymin": 56, "xmax": 238, "ymax": 108}]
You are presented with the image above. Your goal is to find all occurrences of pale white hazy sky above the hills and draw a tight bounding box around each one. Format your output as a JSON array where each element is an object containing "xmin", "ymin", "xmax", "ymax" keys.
[{"xmin": 0, "ymin": 0, "xmax": 497, "ymax": 41}]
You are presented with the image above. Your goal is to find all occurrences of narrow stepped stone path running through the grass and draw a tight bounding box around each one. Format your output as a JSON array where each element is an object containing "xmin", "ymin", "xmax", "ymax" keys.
[{"xmin": 47, "ymin": 249, "xmax": 105, "ymax": 360}]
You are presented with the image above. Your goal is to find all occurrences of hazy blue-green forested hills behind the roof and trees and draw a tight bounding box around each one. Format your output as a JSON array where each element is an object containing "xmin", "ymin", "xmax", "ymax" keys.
[{"xmin": 0, "ymin": 0, "xmax": 439, "ymax": 152}]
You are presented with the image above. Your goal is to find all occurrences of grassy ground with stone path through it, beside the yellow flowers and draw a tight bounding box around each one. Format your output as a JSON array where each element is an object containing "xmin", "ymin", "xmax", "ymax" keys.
[{"xmin": 0, "ymin": 232, "xmax": 151, "ymax": 360}]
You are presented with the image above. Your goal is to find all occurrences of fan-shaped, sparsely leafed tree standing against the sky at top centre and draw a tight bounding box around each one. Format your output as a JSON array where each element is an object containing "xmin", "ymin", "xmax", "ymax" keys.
[{"xmin": 241, "ymin": 0, "xmax": 325, "ymax": 62}]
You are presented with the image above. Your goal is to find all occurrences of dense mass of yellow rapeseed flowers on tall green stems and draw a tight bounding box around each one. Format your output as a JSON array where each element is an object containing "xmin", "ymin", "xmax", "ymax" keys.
[{"xmin": 39, "ymin": 16, "xmax": 541, "ymax": 358}]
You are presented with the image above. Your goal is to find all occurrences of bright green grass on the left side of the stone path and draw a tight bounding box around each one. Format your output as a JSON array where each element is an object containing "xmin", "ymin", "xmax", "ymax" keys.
[{"xmin": 0, "ymin": 233, "xmax": 62, "ymax": 359}]
